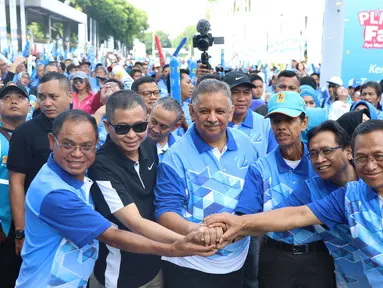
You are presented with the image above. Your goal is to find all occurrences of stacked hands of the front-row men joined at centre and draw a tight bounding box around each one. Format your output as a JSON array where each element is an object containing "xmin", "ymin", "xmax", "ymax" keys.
[{"xmin": 173, "ymin": 213, "xmax": 249, "ymax": 256}]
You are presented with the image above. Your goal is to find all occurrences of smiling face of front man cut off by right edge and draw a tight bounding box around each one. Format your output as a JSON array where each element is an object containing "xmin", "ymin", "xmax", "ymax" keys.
[{"xmin": 354, "ymin": 130, "xmax": 383, "ymax": 196}]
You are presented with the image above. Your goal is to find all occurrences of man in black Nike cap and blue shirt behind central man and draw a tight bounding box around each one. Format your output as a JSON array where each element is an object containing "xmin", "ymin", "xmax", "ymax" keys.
[{"xmin": 223, "ymin": 71, "xmax": 277, "ymax": 157}]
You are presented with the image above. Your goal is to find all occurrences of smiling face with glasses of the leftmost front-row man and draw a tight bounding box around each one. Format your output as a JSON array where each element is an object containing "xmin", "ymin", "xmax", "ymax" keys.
[{"xmin": 48, "ymin": 121, "xmax": 98, "ymax": 181}]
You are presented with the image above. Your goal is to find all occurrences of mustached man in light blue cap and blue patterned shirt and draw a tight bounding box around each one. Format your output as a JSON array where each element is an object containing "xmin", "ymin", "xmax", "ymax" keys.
[{"xmin": 236, "ymin": 91, "xmax": 335, "ymax": 288}]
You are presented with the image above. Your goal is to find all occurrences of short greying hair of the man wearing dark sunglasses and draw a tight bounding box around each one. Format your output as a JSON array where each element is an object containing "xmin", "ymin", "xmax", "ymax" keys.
[{"xmin": 106, "ymin": 90, "xmax": 147, "ymax": 121}]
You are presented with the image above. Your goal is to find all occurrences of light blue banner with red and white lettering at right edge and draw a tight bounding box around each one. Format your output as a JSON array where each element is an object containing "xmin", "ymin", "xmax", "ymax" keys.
[{"xmin": 341, "ymin": 0, "xmax": 383, "ymax": 83}]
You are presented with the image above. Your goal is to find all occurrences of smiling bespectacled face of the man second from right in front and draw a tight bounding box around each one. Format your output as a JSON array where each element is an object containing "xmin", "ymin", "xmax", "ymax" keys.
[{"xmin": 308, "ymin": 131, "xmax": 352, "ymax": 180}]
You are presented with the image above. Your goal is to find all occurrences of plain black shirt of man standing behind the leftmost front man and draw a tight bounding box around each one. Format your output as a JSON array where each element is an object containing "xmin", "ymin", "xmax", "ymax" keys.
[{"xmin": 7, "ymin": 114, "xmax": 53, "ymax": 192}]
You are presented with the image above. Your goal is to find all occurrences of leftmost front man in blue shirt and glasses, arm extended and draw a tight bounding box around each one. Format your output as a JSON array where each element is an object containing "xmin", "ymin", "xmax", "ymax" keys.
[{"xmin": 16, "ymin": 110, "xmax": 215, "ymax": 287}]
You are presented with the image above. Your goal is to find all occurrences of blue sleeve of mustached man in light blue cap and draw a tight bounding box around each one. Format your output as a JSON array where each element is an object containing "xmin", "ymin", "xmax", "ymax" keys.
[{"xmin": 235, "ymin": 165, "xmax": 263, "ymax": 214}]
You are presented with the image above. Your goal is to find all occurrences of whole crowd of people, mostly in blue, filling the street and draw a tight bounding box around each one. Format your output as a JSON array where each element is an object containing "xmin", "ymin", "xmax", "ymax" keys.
[{"xmin": 0, "ymin": 52, "xmax": 383, "ymax": 288}]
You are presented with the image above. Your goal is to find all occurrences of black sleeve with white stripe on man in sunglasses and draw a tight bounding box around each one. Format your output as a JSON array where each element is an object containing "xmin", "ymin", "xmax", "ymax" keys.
[{"xmin": 88, "ymin": 164, "xmax": 134, "ymax": 217}]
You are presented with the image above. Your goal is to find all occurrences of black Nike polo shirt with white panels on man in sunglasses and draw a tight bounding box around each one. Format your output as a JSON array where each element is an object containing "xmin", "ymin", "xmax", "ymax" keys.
[{"xmin": 88, "ymin": 136, "xmax": 161, "ymax": 287}]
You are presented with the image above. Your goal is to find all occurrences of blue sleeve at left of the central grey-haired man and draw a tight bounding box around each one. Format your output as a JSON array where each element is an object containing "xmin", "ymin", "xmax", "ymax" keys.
[{"xmin": 154, "ymin": 163, "xmax": 187, "ymax": 219}]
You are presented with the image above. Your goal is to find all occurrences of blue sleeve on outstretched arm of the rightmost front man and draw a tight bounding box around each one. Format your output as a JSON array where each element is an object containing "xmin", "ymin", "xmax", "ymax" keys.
[{"xmin": 307, "ymin": 188, "xmax": 348, "ymax": 228}]
